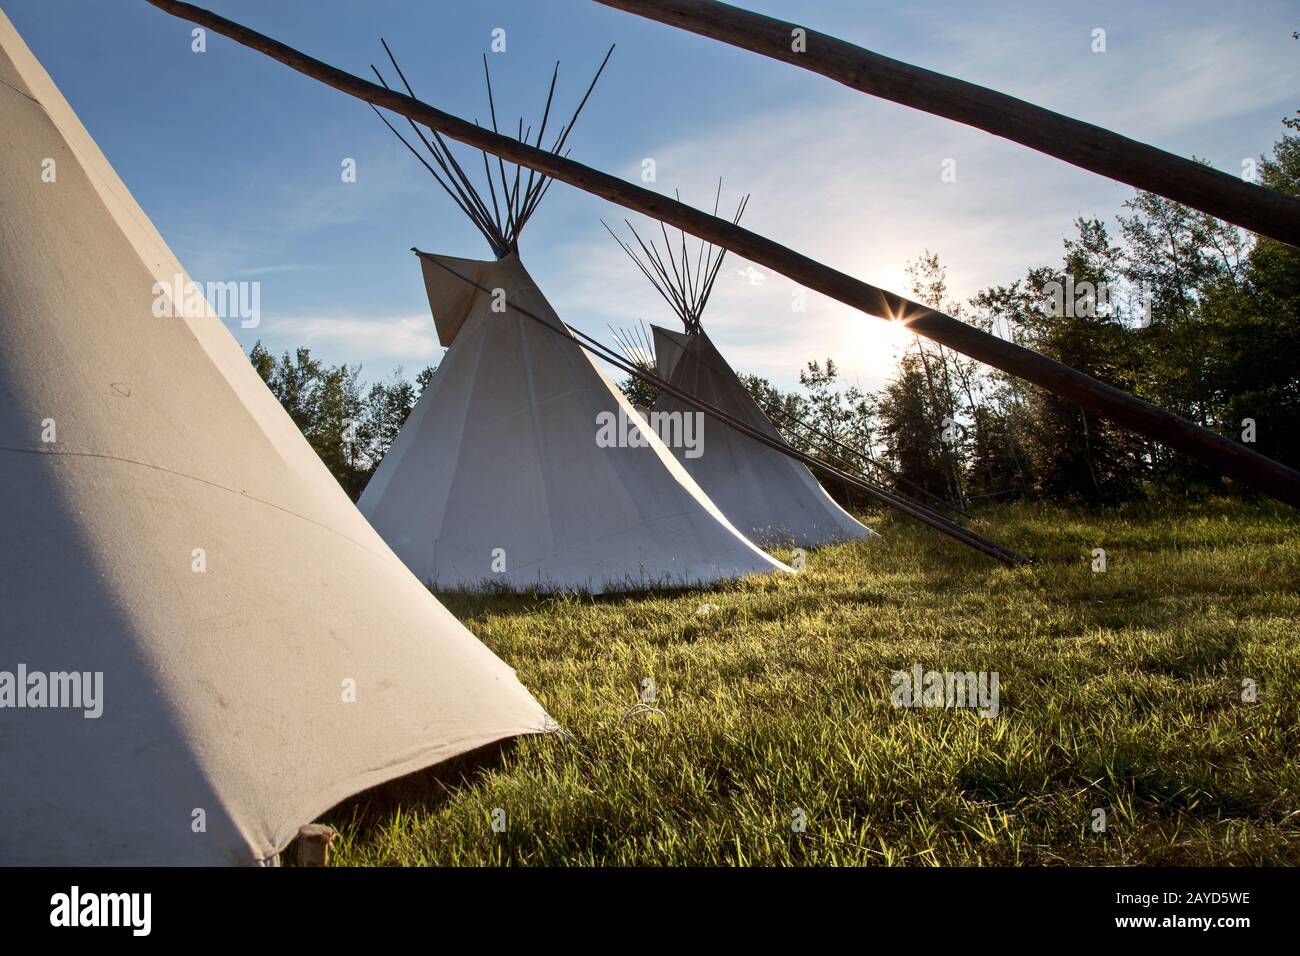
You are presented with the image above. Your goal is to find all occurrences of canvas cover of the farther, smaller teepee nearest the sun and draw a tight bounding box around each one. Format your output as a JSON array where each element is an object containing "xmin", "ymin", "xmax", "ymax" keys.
[{"xmin": 651, "ymin": 325, "xmax": 872, "ymax": 548}]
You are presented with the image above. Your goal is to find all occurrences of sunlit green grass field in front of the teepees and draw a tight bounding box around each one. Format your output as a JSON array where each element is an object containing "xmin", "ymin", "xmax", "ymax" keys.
[{"xmin": 324, "ymin": 501, "xmax": 1300, "ymax": 865}]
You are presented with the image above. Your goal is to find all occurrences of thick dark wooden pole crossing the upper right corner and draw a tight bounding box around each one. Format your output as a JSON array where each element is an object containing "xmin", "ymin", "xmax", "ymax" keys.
[{"xmin": 597, "ymin": 0, "xmax": 1300, "ymax": 246}]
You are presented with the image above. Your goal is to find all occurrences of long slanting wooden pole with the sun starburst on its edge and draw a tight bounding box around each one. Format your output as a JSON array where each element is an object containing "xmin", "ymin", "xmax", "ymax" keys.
[{"xmin": 142, "ymin": 0, "xmax": 1300, "ymax": 507}]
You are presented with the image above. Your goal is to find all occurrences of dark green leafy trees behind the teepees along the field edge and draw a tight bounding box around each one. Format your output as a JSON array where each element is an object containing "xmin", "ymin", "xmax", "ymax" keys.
[{"xmin": 250, "ymin": 114, "xmax": 1300, "ymax": 506}]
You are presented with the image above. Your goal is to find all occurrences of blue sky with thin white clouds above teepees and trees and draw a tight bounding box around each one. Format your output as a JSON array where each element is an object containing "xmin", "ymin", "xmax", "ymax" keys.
[{"xmin": 10, "ymin": 0, "xmax": 1300, "ymax": 388}]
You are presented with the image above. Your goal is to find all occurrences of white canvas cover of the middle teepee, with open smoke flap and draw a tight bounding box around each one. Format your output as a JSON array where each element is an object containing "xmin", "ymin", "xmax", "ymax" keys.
[{"xmin": 359, "ymin": 252, "xmax": 787, "ymax": 592}]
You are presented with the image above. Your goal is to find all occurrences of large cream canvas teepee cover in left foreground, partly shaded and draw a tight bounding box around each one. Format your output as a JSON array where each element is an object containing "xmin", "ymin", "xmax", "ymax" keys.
[{"xmin": 0, "ymin": 14, "xmax": 549, "ymax": 864}]
